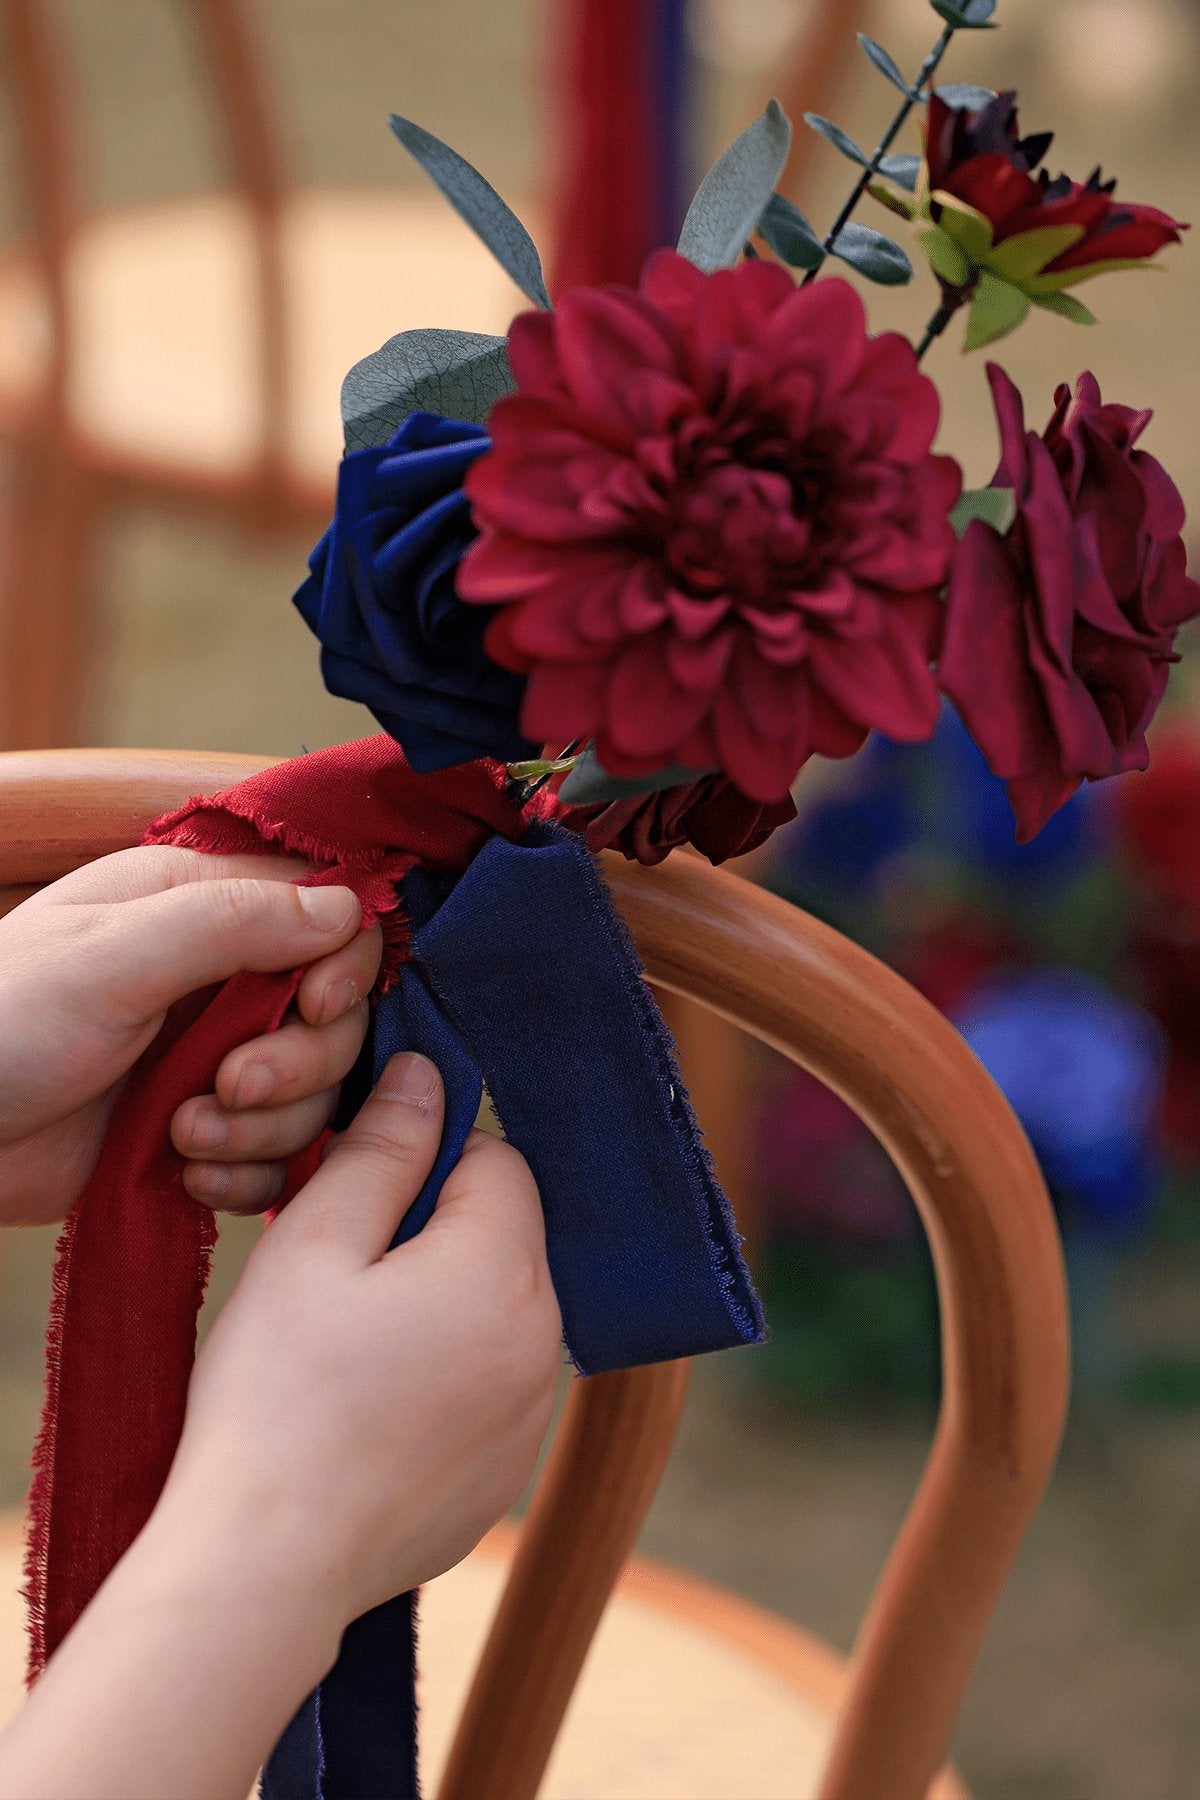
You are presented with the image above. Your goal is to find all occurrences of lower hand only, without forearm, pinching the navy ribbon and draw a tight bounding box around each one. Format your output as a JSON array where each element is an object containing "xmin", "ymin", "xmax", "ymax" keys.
[{"xmin": 155, "ymin": 1055, "xmax": 561, "ymax": 1634}]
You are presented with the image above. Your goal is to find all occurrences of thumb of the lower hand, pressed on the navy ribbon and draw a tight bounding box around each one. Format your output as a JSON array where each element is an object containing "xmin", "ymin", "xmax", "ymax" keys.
[{"xmin": 268, "ymin": 1049, "xmax": 444, "ymax": 1264}]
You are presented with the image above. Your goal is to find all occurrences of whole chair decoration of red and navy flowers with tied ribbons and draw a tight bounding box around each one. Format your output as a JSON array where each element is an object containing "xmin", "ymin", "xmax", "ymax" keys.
[{"xmin": 31, "ymin": 0, "xmax": 1200, "ymax": 1800}]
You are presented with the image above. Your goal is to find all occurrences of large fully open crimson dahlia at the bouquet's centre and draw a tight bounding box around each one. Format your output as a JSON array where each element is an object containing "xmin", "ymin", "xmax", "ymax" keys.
[{"xmin": 459, "ymin": 250, "xmax": 961, "ymax": 803}]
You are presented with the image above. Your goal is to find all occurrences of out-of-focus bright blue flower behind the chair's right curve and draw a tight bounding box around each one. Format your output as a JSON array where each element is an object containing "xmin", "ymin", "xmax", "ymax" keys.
[{"xmin": 954, "ymin": 968, "xmax": 1166, "ymax": 1237}]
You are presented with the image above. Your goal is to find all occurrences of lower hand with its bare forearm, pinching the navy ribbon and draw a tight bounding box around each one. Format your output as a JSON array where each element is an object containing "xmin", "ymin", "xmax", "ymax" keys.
[{"xmin": 0, "ymin": 1055, "xmax": 560, "ymax": 1800}]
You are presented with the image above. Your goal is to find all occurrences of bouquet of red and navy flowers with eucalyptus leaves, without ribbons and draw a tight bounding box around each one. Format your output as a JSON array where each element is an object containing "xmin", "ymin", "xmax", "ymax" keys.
[{"xmin": 297, "ymin": 0, "xmax": 1200, "ymax": 862}]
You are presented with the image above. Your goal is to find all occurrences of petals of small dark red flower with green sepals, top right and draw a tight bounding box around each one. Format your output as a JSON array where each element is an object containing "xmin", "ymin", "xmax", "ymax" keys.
[{"xmin": 925, "ymin": 94, "xmax": 1187, "ymax": 275}]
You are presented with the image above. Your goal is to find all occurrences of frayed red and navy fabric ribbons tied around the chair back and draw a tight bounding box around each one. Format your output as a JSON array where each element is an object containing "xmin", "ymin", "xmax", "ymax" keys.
[{"xmin": 27, "ymin": 736, "xmax": 761, "ymax": 1800}]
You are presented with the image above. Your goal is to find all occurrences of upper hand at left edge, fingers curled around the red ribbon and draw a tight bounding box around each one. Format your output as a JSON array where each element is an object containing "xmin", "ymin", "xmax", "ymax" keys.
[{"xmin": 0, "ymin": 846, "xmax": 381, "ymax": 1224}]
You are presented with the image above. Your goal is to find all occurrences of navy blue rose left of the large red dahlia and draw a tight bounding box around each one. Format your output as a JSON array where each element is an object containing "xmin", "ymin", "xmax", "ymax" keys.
[{"xmin": 295, "ymin": 412, "xmax": 536, "ymax": 772}]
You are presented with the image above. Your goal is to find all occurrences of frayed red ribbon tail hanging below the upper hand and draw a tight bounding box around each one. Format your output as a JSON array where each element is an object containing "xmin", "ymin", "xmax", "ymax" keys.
[{"xmin": 25, "ymin": 972, "xmax": 300, "ymax": 1681}]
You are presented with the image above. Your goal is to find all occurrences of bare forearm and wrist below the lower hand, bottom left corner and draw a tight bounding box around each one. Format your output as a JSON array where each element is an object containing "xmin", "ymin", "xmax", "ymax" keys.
[{"xmin": 0, "ymin": 1489, "xmax": 342, "ymax": 1800}]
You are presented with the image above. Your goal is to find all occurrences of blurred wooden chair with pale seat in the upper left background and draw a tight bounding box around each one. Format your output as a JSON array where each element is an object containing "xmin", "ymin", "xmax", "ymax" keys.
[{"xmin": 0, "ymin": 0, "xmax": 871, "ymax": 749}]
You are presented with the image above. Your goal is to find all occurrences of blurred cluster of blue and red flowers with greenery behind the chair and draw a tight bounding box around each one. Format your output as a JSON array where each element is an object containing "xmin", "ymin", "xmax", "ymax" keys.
[{"xmin": 752, "ymin": 709, "xmax": 1200, "ymax": 1406}]
